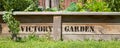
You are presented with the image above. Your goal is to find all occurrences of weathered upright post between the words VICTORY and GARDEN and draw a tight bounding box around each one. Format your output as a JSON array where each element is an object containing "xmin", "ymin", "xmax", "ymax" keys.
[{"xmin": 53, "ymin": 16, "xmax": 62, "ymax": 41}]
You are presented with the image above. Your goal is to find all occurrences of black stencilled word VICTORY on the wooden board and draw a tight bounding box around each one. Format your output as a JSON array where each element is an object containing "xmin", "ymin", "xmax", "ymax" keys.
[{"xmin": 21, "ymin": 26, "xmax": 52, "ymax": 32}]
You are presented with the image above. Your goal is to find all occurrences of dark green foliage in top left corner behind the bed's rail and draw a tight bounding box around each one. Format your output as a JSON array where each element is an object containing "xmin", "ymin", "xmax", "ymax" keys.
[{"xmin": 0, "ymin": 0, "xmax": 38, "ymax": 11}]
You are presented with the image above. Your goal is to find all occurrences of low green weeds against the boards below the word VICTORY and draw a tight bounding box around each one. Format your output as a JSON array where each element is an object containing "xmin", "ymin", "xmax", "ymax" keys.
[{"xmin": 23, "ymin": 32, "xmax": 52, "ymax": 42}]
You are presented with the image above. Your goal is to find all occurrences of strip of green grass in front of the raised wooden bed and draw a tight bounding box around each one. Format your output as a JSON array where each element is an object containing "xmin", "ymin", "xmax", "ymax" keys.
[{"xmin": 0, "ymin": 38, "xmax": 120, "ymax": 48}]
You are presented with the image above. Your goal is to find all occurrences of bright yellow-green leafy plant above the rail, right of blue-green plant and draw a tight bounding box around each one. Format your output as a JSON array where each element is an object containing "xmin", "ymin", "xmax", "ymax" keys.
[{"xmin": 85, "ymin": 0, "xmax": 111, "ymax": 12}]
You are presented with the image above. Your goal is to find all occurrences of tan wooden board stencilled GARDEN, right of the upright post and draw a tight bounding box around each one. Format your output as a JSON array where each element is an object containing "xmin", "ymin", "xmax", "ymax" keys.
[{"xmin": 63, "ymin": 23, "xmax": 120, "ymax": 34}]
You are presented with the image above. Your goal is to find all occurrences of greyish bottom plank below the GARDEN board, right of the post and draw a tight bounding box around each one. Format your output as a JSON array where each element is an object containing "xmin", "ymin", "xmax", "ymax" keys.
[{"xmin": 63, "ymin": 34, "xmax": 120, "ymax": 40}]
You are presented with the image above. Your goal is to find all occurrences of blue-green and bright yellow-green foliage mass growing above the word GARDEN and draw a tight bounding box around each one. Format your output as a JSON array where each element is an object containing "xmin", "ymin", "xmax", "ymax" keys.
[{"xmin": 66, "ymin": 0, "xmax": 111, "ymax": 12}]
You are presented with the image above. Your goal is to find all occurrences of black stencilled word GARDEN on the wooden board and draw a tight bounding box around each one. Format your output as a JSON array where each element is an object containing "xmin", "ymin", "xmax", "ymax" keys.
[{"xmin": 64, "ymin": 26, "xmax": 95, "ymax": 32}]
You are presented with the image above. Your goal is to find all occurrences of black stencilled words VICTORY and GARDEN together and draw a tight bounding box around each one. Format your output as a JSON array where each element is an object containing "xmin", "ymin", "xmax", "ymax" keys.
[{"xmin": 21, "ymin": 26, "xmax": 95, "ymax": 32}]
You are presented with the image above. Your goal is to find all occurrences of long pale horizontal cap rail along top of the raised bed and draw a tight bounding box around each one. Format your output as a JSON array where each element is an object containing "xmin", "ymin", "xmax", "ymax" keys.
[{"xmin": 11, "ymin": 12, "xmax": 120, "ymax": 15}]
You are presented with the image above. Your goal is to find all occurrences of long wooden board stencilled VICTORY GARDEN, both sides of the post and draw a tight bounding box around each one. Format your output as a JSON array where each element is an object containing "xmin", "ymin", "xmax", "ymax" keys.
[{"xmin": 2, "ymin": 23, "xmax": 120, "ymax": 34}]
